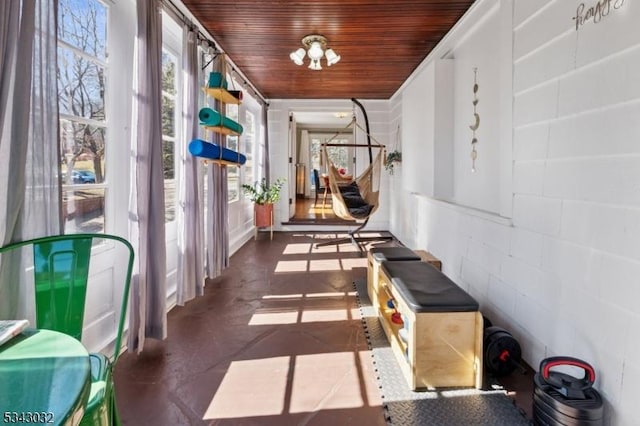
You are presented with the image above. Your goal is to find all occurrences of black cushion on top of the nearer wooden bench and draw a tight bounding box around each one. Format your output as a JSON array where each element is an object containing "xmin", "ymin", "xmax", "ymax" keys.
[{"xmin": 381, "ymin": 261, "xmax": 479, "ymax": 312}]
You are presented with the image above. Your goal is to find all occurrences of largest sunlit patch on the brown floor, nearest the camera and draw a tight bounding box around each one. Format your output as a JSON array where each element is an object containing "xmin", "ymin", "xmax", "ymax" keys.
[{"xmin": 203, "ymin": 351, "xmax": 382, "ymax": 420}]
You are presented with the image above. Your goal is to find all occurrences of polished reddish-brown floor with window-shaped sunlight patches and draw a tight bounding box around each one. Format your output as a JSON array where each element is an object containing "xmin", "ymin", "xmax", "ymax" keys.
[{"xmin": 115, "ymin": 232, "xmax": 531, "ymax": 425}]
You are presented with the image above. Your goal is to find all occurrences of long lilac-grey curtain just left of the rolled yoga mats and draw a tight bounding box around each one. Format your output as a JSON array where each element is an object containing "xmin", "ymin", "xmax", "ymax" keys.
[{"xmin": 177, "ymin": 24, "xmax": 204, "ymax": 305}]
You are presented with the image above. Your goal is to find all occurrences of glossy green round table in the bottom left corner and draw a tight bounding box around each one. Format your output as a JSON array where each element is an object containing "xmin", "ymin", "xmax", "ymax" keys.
[{"xmin": 0, "ymin": 329, "xmax": 91, "ymax": 425}]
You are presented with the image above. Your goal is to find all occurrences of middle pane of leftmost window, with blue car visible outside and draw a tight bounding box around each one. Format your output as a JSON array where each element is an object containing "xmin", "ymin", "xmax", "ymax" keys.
[{"xmin": 60, "ymin": 120, "xmax": 106, "ymax": 185}]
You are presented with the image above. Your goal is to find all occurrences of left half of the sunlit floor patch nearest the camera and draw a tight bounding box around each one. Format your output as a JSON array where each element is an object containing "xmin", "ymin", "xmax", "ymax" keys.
[{"xmin": 203, "ymin": 356, "xmax": 290, "ymax": 420}]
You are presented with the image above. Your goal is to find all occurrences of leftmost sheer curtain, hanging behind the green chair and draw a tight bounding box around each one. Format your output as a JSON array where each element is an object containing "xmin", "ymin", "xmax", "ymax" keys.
[{"xmin": 0, "ymin": 0, "xmax": 61, "ymax": 318}]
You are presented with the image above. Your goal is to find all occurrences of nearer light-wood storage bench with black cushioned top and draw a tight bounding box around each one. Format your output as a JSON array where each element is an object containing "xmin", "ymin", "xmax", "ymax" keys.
[{"xmin": 371, "ymin": 260, "xmax": 483, "ymax": 389}]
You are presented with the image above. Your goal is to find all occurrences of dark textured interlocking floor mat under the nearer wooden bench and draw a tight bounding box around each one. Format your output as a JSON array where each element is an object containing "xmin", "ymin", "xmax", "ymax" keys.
[{"xmin": 354, "ymin": 278, "xmax": 531, "ymax": 426}]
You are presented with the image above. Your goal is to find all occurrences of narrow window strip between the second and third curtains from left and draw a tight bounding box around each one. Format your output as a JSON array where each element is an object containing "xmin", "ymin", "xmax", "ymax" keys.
[{"xmin": 162, "ymin": 49, "xmax": 178, "ymax": 223}]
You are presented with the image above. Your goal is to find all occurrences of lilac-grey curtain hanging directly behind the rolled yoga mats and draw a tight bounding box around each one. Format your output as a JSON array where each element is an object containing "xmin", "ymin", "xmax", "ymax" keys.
[{"xmin": 206, "ymin": 54, "xmax": 229, "ymax": 278}]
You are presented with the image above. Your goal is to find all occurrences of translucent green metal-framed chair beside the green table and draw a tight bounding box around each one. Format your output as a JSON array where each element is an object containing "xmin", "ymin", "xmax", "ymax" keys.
[{"xmin": 0, "ymin": 234, "xmax": 134, "ymax": 425}]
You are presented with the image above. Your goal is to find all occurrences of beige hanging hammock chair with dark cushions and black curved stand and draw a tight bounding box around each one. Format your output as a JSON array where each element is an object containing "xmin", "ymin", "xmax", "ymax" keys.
[{"xmin": 316, "ymin": 99, "xmax": 393, "ymax": 252}]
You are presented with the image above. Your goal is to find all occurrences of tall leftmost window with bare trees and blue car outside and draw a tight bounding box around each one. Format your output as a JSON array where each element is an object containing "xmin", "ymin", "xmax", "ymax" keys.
[{"xmin": 57, "ymin": 0, "xmax": 108, "ymax": 232}]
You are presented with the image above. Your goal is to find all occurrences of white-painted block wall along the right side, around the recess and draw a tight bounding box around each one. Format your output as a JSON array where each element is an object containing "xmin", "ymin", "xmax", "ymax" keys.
[{"xmin": 390, "ymin": 0, "xmax": 640, "ymax": 425}]
